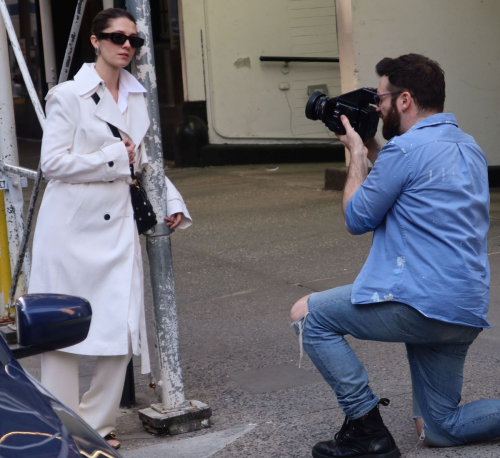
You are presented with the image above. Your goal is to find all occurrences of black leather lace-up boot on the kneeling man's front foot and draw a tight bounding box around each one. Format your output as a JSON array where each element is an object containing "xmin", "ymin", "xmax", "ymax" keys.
[{"xmin": 313, "ymin": 398, "xmax": 401, "ymax": 458}]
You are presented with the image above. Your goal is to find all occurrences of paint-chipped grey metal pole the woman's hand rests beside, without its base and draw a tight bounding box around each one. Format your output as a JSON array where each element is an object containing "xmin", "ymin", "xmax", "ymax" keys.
[{"xmin": 127, "ymin": 0, "xmax": 185, "ymax": 409}]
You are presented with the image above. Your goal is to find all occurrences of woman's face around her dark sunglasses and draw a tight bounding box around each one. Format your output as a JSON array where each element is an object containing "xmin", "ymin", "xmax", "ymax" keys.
[{"xmin": 92, "ymin": 17, "xmax": 137, "ymax": 67}]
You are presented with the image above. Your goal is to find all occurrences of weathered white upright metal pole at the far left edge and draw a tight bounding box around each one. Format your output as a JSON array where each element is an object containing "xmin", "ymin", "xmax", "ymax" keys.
[{"xmin": 0, "ymin": 12, "xmax": 29, "ymax": 306}]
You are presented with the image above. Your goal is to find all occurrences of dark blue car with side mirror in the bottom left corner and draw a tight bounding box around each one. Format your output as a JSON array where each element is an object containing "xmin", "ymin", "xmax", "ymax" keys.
[{"xmin": 0, "ymin": 294, "xmax": 120, "ymax": 458}]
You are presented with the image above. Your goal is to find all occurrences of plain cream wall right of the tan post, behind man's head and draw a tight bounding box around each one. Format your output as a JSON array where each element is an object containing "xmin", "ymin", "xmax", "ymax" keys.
[{"xmin": 348, "ymin": 0, "xmax": 500, "ymax": 165}]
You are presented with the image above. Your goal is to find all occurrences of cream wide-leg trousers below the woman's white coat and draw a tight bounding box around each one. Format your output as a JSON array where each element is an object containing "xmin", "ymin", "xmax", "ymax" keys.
[{"xmin": 42, "ymin": 348, "xmax": 132, "ymax": 437}]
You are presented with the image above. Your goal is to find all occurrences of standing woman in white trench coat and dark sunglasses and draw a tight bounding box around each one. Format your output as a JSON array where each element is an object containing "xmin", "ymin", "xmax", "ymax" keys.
[{"xmin": 29, "ymin": 8, "xmax": 191, "ymax": 448}]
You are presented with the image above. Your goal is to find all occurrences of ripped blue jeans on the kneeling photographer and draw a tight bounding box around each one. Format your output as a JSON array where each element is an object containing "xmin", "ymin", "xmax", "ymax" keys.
[{"xmin": 293, "ymin": 285, "xmax": 500, "ymax": 447}]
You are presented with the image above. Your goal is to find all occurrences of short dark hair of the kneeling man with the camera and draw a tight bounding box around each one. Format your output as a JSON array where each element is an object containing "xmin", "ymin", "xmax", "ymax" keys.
[{"xmin": 376, "ymin": 54, "xmax": 446, "ymax": 113}]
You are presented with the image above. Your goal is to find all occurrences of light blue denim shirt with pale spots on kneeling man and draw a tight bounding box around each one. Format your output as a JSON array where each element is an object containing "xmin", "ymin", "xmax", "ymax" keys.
[{"xmin": 345, "ymin": 113, "xmax": 490, "ymax": 327}]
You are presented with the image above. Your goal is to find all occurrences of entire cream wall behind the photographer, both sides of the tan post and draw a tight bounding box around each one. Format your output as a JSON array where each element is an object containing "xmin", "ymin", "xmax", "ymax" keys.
[{"xmin": 179, "ymin": 0, "xmax": 500, "ymax": 157}]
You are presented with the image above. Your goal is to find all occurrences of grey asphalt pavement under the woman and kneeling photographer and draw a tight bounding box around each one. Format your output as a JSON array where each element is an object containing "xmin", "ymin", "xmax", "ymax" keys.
[{"xmin": 16, "ymin": 141, "xmax": 500, "ymax": 458}]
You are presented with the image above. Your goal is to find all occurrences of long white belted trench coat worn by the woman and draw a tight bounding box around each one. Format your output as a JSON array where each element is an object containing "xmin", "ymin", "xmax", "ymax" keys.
[{"xmin": 29, "ymin": 64, "xmax": 191, "ymax": 373}]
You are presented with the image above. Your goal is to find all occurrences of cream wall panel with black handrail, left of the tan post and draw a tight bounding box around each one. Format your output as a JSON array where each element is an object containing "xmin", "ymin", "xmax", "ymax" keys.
[{"xmin": 181, "ymin": 0, "xmax": 341, "ymax": 143}]
